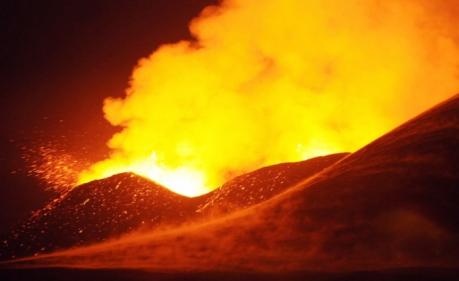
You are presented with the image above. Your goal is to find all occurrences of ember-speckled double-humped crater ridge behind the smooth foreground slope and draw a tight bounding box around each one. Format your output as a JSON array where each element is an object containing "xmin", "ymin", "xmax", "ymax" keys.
[{"xmin": 0, "ymin": 153, "xmax": 347, "ymax": 259}]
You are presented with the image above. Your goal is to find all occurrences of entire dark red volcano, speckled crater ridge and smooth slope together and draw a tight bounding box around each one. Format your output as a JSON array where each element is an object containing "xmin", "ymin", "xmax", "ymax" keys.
[{"xmin": 0, "ymin": 95, "xmax": 459, "ymax": 280}]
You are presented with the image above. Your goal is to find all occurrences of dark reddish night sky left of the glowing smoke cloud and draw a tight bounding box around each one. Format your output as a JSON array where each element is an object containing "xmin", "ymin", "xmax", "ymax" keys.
[{"xmin": 0, "ymin": 0, "xmax": 217, "ymax": 232}]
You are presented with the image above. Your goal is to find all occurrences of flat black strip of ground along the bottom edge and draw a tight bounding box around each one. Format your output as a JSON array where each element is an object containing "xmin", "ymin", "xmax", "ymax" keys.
[{"xmin": 0, "ymin": 268, "xmax": 459, "ymax": 281}]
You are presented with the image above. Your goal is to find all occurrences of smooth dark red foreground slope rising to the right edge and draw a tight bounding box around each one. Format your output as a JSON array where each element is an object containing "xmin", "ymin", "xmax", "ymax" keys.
[{"xmin": 17, "ymin": 96, "xmax": 459, "ymax": 272}]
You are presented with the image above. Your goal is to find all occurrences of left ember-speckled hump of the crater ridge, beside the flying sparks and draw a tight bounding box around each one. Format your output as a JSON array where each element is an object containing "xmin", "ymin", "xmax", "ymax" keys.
[{"xmin": 0, "ymin": 173, "xmax": 199, "ymax": 259}]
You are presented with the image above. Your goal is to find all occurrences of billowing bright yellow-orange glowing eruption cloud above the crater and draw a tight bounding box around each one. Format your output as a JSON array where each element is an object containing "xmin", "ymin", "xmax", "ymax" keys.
[{"xmin": 80, "ymin": 0, "xmax": 459, "ymax": 196}]
